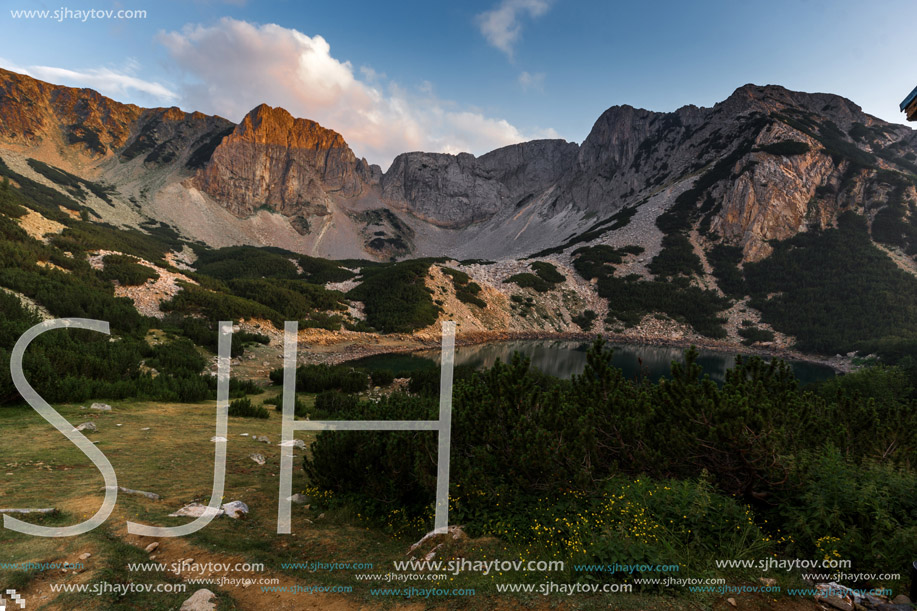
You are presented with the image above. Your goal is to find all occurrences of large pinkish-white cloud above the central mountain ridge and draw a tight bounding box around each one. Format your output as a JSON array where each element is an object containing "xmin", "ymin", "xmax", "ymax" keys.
[{"xmin": 159, "ymin": 18, "xmax": 556, "ymax": 167}]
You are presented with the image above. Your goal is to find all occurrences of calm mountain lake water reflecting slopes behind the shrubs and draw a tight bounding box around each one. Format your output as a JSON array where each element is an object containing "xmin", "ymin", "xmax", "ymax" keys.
[{"xmin": 351, "ymin": 340, "xmax": 835, "ymax": 384}]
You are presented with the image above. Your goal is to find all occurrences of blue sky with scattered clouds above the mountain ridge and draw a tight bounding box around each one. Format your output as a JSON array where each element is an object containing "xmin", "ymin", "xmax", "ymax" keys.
[{"xmin": 0, "ymin": 0, "xmax": 917, "ymax": 166}]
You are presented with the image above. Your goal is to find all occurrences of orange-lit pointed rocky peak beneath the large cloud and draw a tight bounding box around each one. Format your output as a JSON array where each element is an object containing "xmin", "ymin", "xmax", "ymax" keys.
[{"xmin": 195, "ymin": 104, "xmax": 380, "ymax": 216}]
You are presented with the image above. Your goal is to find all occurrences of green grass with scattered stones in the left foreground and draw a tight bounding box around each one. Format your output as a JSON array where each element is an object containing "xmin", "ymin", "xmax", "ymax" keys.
[{"xmin": 0, "ymin": 395, "xmax": 690, "ymax": 611}]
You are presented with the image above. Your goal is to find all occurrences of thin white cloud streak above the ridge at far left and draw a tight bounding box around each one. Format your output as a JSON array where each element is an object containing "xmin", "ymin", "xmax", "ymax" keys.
[{"xmin": 3, "ymin": 59, "xmax": 178, "ymax": 105}]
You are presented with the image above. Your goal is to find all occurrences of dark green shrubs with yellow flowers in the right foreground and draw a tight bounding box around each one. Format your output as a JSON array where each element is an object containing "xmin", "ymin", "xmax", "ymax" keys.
[{"xmin": 304, "ymin": 342, "xmax": 917, "ymax": 580}]
